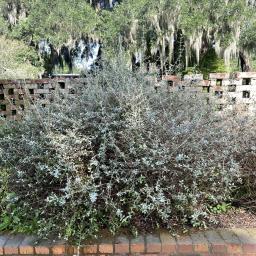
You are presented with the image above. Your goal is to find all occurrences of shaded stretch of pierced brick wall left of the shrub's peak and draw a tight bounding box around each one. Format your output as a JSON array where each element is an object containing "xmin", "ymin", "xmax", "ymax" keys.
[{"xmin": 0, "ymin": 78, "xmax": 84, "ymax": 120}]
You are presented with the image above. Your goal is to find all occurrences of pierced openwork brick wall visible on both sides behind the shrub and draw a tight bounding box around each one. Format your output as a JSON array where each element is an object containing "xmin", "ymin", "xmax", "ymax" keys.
[{"xmin": 0, "ymin": 72, "xmax": 256, "ymax": 120}]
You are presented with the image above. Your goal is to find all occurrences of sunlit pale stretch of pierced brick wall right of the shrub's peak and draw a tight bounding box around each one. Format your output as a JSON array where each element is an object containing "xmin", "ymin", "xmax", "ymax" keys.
[{"xmin": 159, "ymin": 72, "xmax": 256, "ymax": 114}]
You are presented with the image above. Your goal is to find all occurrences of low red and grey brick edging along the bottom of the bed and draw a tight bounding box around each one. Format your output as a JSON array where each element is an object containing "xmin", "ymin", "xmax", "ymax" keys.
[{"xmin": 0, "ymin": 229, "xmax": 256, "ymax": 256}]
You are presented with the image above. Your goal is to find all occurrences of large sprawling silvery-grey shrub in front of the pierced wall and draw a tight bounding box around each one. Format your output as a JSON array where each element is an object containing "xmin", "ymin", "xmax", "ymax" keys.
[{"xmin": 0, "ymin": 59, "xmax": 244, "ymax": 242}]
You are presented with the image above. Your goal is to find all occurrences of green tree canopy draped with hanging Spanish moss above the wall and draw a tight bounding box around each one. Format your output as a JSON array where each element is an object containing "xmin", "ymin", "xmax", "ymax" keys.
[{"xmin": 0, "ymin": 0, "xmax": 256, "ymax": 75}]
